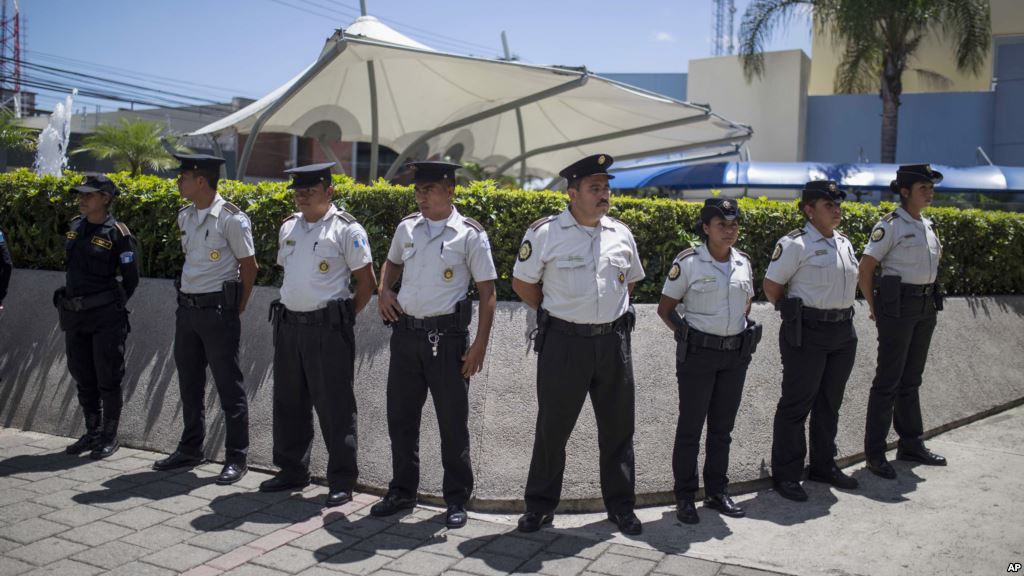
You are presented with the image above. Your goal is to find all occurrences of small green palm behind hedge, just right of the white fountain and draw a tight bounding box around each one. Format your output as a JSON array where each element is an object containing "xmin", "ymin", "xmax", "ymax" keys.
[{"xmin": 72, "ymin": 118, "xmax": 185, "ymax": 176}]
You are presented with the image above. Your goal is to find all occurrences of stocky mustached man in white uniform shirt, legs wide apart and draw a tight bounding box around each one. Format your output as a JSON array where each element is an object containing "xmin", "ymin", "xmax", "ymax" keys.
[{"xmin": 512, "ymin": 154, "xmax": 644, "ymax": 534}]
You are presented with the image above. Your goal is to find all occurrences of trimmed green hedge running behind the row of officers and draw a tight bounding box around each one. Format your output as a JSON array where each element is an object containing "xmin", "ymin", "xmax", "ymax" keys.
[{"xmin": 0, "ymin": 170, "xmax": 1024, "ymax": 302}]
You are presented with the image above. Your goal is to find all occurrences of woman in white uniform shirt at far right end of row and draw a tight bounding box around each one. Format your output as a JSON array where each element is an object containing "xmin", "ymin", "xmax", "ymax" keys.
[{"xmin": 860, "ymin": 164, "xmax": 946, "ymax": 479}]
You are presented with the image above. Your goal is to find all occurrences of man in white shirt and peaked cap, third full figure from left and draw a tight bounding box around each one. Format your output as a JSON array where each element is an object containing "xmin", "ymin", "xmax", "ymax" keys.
[{"xmin": 260, "ymin": 162, "xmax": 377, "ymax": 506}]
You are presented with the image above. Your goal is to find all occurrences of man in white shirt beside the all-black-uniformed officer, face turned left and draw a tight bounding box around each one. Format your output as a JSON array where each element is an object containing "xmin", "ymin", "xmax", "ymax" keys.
[{"xmin": 153, "ymin": 154, "xmax": 258, "ymax": 484}]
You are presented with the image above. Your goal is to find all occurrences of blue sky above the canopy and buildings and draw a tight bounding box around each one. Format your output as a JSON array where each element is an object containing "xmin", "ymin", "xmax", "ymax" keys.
[{"xmin": 14, "ymin": 0, "xmax": 811, "ymax": 111}]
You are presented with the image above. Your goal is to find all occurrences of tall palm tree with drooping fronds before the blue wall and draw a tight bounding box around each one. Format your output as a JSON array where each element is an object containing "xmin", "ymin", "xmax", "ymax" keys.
[{"xmin": 739, "ymin": 0, "xmax": 991, "ymax": 163}]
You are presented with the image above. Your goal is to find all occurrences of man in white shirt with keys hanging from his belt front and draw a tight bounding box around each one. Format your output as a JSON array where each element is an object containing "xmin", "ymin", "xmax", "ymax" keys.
[{"xmin": 370, "ymin": 162, "xmax": 498, "ymax": 528}]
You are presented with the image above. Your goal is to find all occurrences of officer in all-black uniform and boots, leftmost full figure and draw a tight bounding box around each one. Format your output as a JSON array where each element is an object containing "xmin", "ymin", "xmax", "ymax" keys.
[{"xmin": 53, "ymin": 174, "xmax": 138, "ymax": 460}]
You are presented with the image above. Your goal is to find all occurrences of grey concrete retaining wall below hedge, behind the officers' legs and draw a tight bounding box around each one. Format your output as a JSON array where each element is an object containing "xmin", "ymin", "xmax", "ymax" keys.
[{"xmin": 0, "ymin": 270, "xmax": 1024, "ymax": 511}]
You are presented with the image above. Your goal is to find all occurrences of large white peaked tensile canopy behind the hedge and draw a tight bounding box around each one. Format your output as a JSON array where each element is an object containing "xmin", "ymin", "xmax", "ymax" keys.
[{"xmin": 193, "ymin": 16, "xmax": 752, "ymax": 179}]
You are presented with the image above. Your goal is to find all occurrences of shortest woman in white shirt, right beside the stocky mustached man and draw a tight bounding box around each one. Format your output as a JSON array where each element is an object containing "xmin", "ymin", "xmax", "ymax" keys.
[{"xmin": 657, "ymin": 198, "xmax": 758, "ymax": 524}]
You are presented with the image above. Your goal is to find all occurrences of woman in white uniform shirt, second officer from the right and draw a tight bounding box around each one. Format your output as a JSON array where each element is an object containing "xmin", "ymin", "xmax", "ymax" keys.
[{"xmin": 764, "ymin": 180, "xmax": 858, "ymax": 501}]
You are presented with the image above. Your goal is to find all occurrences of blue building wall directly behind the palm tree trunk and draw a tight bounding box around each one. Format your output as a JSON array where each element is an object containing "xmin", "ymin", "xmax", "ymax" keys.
[{"xmin": 802, "ymin": 92, "xmax": 995, "ymax": 166}]
